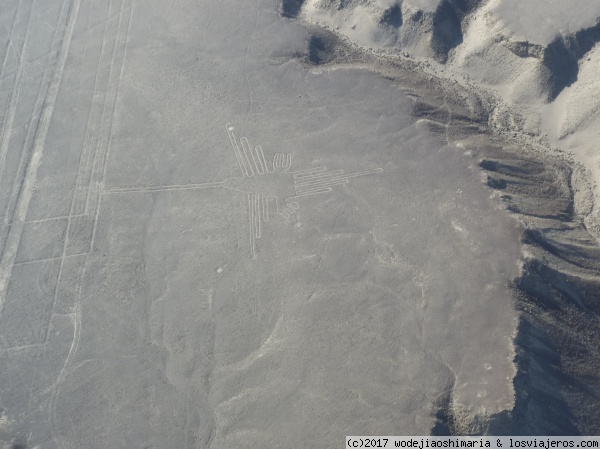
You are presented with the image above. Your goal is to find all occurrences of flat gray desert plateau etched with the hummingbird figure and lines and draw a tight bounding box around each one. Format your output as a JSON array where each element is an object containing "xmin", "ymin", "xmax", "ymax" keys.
[{"xmin": 0, "ymin": 0, "xmax": 596, "ymax": 448}]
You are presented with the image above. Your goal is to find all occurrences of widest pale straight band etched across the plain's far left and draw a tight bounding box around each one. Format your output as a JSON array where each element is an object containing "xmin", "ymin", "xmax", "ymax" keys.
[{"xmin": 0, "ymin": 0, "xmax": 81, "ymax": 317}]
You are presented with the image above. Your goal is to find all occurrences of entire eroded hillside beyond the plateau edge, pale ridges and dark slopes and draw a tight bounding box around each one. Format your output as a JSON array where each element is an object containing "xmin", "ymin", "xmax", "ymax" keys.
[{"xmin": 282, "ymin": 0, "xmax": 600, "ymax": 435}]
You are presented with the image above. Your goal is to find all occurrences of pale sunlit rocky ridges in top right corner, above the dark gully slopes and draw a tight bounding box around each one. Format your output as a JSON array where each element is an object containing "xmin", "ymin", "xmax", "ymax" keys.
[{"xmin": 282, "ymin": 0, "xmax": 600, "ymax": 226}]
